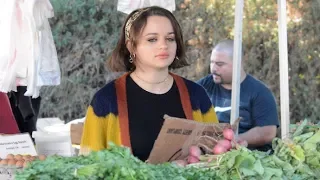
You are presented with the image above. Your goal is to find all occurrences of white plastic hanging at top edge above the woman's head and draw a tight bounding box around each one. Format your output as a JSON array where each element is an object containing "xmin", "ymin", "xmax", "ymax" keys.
[{"xmin": 117, "ymin": 0, "xmax": 176, "ymax": 14}]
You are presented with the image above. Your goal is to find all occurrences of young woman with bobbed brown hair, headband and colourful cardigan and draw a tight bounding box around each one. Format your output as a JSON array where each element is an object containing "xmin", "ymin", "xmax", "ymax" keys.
[{"xmin": 81, "ymin": 6, "xmax": 218, "ymax": 161}]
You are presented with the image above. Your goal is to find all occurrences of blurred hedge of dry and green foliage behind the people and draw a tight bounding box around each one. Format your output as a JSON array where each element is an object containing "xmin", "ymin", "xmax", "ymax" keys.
[{"xmin": 40, "ymin": 0, "xmax": 320, "ymax": 123}]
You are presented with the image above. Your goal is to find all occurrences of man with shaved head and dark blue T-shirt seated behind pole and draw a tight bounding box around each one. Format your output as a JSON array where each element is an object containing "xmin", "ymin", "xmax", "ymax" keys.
[{"xmin": 198, "ymin": 40, "xmax": 279, "ymax": 151}]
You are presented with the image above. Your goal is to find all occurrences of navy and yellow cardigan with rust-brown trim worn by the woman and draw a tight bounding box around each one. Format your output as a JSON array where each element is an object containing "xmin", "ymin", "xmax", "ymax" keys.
[{"xmin": 80, "ymin": 73, "xmax": 218, "ymax": 153}]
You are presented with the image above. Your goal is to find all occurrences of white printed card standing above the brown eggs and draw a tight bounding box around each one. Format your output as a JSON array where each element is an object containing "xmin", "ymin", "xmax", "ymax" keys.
[{"xmin": 0, "ymin": 133, "xmax": 37, "ymax": 159}]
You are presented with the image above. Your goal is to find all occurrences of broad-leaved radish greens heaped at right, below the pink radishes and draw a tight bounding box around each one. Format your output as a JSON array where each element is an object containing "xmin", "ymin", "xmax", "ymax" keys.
[{"xmin": 192, "ymin": 120, "xmax": 320, "ymax": 180}]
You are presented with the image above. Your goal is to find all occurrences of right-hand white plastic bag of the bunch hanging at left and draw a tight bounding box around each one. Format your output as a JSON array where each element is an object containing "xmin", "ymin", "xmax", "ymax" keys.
[{"xmin": 25, "ymin": 0, "xmax": 60, "ymax": 97}]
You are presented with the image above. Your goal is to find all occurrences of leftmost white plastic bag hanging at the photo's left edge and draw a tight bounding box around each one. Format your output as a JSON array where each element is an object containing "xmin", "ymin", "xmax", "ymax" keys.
[{"xmin": 0, "ymin": 0, "xmax": 32, "ymax": 93}]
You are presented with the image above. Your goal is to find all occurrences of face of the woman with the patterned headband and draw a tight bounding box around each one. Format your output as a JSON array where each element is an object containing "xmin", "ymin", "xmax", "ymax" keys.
[{"xmin": 134, "ymin": 16, "xmax": 177, "ymax": 70}]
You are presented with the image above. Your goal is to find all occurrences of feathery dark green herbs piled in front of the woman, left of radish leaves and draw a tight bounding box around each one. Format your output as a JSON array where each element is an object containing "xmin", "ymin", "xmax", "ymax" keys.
[{"xmin": 15, "ymin": 144, "xmax": 219, "ymax": 180}]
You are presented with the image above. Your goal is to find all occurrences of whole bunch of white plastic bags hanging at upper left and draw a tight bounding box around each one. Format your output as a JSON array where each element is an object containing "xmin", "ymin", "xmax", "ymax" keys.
[{"xmin": 0, "ymin": 0, "xmax": 60, "ymax": 98}]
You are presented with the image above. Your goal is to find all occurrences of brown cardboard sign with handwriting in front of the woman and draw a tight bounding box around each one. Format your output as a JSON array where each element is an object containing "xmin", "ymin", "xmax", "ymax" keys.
[{"xmin": 147, "ymin": 116, "xmax": 234, "ymax": 164}]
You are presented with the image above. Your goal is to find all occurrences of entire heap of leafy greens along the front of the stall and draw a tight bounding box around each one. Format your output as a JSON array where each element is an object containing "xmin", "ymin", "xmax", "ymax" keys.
[{"xmin": 15, "ymin": 121, "xmax": 320, "ymax": 180}]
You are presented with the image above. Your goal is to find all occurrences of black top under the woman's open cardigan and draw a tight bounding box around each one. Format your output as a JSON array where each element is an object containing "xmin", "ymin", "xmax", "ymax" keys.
[{"xmin": 126, "ymin": 76, "xmax": 186, "ymax": 161}]
